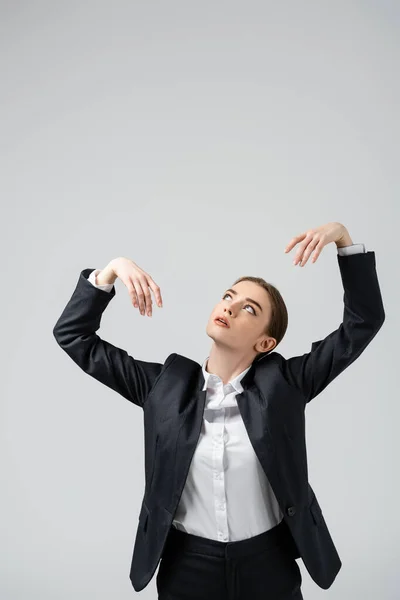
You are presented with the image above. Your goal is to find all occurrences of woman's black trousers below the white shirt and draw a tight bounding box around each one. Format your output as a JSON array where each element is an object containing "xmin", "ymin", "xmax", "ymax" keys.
[{"xmin": 156, "ymin": 520, "xmax": 303, "ymax": 600}]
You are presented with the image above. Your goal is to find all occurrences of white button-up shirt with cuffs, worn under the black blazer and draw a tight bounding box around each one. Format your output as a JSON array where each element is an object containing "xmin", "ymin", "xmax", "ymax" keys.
[{"xmin": 89, "ymin": 244, "xmax": 366, "ymax": 542}]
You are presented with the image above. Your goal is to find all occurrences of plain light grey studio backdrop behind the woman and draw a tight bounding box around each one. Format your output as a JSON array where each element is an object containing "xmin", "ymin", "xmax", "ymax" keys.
[{"xmin": 0, "ymin": 0, "xmax": 400, "ymax": 600}]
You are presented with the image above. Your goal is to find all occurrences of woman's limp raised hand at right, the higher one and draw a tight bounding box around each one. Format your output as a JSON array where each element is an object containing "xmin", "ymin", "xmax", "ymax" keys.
[{"xmin": 285, "ymin": 222, "xmax": 353, "ymax": 267}]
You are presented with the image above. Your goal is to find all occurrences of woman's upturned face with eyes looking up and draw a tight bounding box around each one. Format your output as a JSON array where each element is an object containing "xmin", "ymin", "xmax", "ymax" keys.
[{"xmin": 206, "ymin": 281, "xmax": 276, "ymax": 356}]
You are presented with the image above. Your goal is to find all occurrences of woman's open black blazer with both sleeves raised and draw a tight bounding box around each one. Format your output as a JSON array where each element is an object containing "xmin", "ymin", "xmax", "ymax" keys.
[{"xmin": 53, "ymin": 252, "xmax": 385, "ymax": 592}]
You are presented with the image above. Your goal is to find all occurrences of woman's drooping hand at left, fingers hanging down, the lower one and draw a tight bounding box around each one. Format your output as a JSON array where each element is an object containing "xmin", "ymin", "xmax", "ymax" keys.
[{"xmin": 110, "ymin": 256, "xmax": 162, "ymax": 317}]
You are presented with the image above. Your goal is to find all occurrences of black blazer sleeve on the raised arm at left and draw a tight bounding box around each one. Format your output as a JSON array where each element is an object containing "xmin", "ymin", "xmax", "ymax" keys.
[{"xmin": 53, "ymin": 269, "xmax": 164, "ymax": 408}]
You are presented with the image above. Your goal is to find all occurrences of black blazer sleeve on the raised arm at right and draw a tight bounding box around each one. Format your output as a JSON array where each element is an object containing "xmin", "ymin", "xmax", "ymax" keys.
[{"xmin": 281, "ymin": 252, "xmax": 385, "ymax": 403}]
